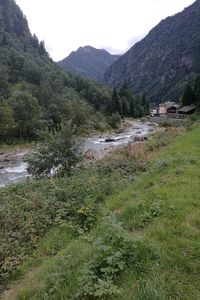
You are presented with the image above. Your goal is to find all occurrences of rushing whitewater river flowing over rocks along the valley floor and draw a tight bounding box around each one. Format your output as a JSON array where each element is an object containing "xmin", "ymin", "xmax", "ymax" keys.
[{"xmin": 0, "ymin": 121, "xmax": 157, "ymax": 187}]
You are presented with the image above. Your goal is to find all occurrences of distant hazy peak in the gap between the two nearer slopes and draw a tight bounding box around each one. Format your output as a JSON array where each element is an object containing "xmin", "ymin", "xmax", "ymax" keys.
[{"xmin": 58, "ymin": 46, "xmax": 120, "ymax": 82}]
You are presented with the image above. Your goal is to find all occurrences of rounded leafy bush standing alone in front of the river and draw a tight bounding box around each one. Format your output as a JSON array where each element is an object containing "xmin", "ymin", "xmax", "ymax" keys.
[{"xmin": 26, "ymin": 124, "xmax": 82, "ymax": 179}]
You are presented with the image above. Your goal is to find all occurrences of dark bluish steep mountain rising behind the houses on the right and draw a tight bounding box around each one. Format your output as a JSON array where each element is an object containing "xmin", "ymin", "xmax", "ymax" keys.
[{"xmin": 105, "ymin": 0, "xmax": 200, "ymax": 103}]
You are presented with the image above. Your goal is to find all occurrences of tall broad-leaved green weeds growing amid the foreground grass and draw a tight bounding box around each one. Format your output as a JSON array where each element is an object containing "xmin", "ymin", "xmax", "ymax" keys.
[{"xmin": 78, "ymin": 213, "xmax": 154, "ymax": 299}]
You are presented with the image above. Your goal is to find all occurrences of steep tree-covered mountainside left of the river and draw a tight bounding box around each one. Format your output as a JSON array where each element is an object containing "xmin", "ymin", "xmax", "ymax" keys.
[{"xmin": 0, "ymin": 0, "xmax": 111, "ymax": 140}]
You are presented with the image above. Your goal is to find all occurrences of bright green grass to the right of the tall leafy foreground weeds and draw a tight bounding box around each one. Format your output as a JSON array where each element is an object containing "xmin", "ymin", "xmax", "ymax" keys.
[{"xmin": 107, "ymin": 129, "xmax": 200, "ymax": 300}]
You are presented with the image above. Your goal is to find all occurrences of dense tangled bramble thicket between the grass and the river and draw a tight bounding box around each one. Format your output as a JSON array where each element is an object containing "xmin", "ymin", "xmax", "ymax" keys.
[{"xmin": 0, "ymin": 154, "xmax": 145, "ymax": 286}]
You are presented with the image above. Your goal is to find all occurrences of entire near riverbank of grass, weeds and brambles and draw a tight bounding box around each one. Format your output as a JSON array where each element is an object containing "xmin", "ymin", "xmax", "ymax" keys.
[{"xmin": 0, "ymin": 121, "xmax": 200, "ymax": 300}]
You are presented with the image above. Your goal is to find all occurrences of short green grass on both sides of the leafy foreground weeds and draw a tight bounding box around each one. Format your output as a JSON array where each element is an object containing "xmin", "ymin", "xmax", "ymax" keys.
[{"xmin": 3, "ymin": 128, "xmax": 200, "ymax": 300}]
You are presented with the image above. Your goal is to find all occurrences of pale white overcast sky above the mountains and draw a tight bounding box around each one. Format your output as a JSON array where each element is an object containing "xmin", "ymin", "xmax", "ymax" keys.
[{"xmin": 16, "ymin": 0, "xmax": 194, "ymax": 61}]
